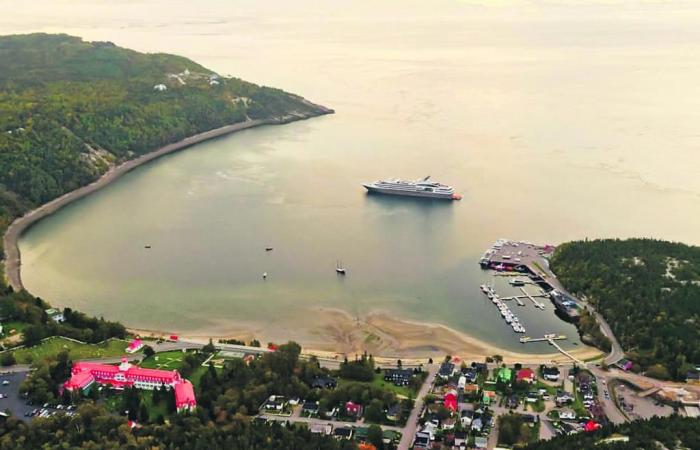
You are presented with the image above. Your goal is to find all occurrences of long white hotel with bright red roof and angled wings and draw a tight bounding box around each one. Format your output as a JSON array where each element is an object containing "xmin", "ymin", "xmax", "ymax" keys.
[{"xmin": 63, "ymin": 357, "xmax": 197, "ymax": 412}]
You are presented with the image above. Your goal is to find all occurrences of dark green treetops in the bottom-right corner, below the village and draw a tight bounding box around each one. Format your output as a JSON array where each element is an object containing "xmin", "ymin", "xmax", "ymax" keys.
[{"xmin": 525, "ymin": 416, "xmax": 700, "ymax": 450}]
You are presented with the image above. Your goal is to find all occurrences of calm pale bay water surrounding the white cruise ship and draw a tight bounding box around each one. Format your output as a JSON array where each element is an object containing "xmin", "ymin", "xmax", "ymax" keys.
[{"xmin": 5, "ymin": 1, "xmax": 700, "ymax": 351}]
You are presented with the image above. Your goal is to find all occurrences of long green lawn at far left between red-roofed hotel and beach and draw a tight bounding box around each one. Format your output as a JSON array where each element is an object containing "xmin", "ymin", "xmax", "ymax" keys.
[{"xmin": 12, "ymin": 337, "xmax": 129, "ymax": 364}]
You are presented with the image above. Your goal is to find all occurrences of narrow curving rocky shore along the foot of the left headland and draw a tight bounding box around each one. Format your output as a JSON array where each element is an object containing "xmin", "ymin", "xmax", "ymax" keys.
[{"xmin": 2, "ymin": 105, "xmax": 335, "ymax": 292}]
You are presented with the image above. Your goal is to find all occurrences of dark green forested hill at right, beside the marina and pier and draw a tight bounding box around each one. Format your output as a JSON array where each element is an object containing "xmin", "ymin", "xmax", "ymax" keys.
[{"xmin": 551, "ymin": 239, "xmax": 700, "ymax": 380}]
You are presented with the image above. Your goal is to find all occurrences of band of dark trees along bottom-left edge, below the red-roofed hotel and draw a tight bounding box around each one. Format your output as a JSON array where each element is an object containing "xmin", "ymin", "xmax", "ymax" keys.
[{"xmin": 0, "ymin": 404, "xmax": 357, "ymax": 450}]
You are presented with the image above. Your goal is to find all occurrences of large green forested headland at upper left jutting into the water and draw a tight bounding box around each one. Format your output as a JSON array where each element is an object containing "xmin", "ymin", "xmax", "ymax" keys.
[{"xmin": 0, "ymin": 34, "xmax": 329, "ymax": 276}]
